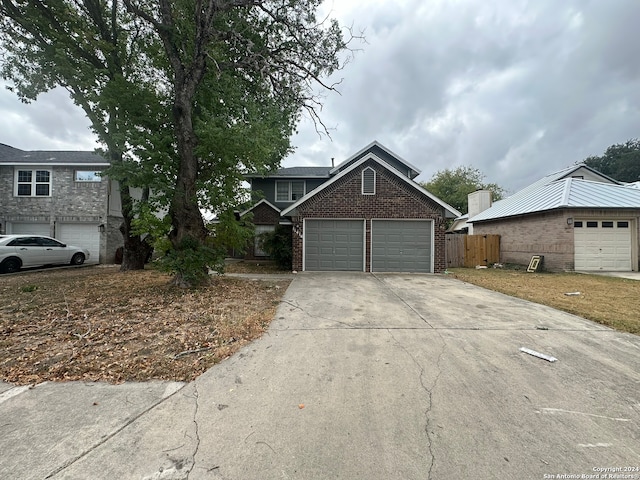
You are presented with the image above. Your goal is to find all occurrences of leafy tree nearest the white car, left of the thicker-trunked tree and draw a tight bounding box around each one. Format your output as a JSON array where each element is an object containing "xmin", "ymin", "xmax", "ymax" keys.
[{"xmin": 0, "ymin": 0, "xmax": 159, "ymax": 270}]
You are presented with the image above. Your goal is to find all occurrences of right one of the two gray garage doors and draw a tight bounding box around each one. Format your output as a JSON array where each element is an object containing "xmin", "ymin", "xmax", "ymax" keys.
[{"xmin": 371, "ymin": 220, "xmax": 433, "ymax": 273}]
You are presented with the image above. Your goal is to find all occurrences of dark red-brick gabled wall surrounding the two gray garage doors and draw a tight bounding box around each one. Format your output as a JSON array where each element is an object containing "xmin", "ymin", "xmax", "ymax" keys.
[{"xmin": 292, "ymin": 160, "xmax": 446, "ymax": 273}]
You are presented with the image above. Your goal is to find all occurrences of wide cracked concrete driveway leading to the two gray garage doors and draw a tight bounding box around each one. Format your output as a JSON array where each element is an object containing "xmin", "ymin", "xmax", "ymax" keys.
[{"xmin": 0, "ymin": 273, "xmax": 640, "ymax": 480}]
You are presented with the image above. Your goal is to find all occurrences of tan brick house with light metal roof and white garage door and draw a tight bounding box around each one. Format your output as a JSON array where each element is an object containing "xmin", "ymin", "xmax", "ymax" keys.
[{"xmin": 467, "ymin": 164, "xmax": 640, "ymax": 271}]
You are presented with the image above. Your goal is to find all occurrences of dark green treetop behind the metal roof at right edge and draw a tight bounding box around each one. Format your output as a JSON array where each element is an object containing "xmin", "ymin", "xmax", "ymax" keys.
[{"xmin": 584, "ymin": 139, "xmax": 640, "ymax": 182}]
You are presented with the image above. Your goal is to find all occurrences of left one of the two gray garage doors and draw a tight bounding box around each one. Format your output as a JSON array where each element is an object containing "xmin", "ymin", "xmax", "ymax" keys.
[{"xmin": 304, "ymin": 220, "xmax": 364, "ymax": 272}]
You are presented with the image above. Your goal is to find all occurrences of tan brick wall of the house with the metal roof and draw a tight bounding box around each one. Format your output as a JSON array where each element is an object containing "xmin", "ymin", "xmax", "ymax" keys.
[{"xmin": 473, "ymin": 209, "xmax": 640, "ymax": 271}]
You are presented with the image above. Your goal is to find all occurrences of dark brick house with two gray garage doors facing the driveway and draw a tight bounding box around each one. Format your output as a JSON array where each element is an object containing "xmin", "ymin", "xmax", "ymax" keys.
[{"xmin": 243, "ymin": 142, "xmax": 460, "ymax": 273}]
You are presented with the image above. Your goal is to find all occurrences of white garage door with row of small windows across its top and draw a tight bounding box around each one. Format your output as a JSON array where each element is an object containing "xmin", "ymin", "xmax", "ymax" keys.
[{"xmin": 573, "ymin": 219, "xmax": 631, "ymax": 272}]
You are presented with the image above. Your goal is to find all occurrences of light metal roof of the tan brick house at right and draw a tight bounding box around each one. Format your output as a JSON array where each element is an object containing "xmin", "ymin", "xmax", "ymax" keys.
[{"xmin": 468, "ymin": 177, "xmax": 640, "ymax": 223}]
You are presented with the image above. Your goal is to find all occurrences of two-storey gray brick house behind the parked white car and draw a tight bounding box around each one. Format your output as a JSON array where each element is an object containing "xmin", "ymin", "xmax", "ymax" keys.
[{"xmin": 0, "ymin": 144, "xmax": 123, "ymax": 263}]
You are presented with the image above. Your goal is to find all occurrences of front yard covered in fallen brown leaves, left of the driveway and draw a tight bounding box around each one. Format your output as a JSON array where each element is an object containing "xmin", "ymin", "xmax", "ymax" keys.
[{"xmin": 0, "ymin": 266, "xmax": 289, "ymax": 384}]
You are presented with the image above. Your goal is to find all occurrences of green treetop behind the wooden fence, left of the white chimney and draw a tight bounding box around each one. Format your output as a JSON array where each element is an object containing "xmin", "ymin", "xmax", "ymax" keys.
[{"xmin": 421, "ymin": 166, "xmax": 505, "ymax": 213}]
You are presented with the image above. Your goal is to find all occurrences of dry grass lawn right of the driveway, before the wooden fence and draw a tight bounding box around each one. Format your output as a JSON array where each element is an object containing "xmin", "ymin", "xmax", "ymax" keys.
[{"xmin": 449, "ymin": 268, "xmax": 640, "ymax": 335}]
